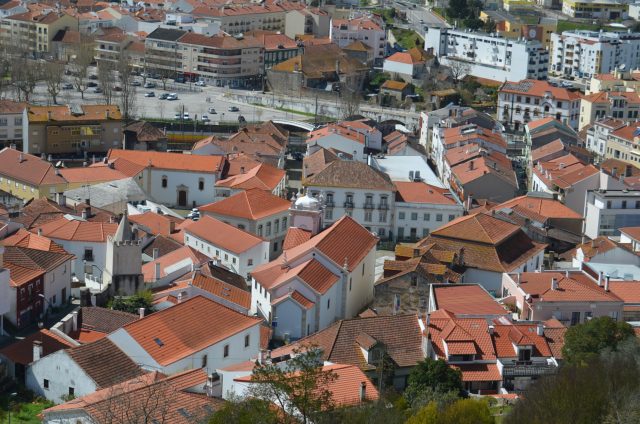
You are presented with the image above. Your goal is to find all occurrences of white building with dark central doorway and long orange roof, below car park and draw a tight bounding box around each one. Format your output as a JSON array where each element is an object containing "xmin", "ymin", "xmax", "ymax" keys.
[{"xmin": 107, "ymin": 149, "xmax": 224, "ymax": 208}]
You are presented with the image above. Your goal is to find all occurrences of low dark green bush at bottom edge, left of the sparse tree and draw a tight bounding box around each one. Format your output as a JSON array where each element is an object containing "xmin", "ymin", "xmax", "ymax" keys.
[{"xmin": 209, "ymin": 398, "xmax": 281, "ymax": 424}]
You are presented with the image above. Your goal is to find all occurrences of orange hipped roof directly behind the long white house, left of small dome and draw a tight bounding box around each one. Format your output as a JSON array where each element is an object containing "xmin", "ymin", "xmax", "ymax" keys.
[{"xmin": 199, "ymin": 189, "xmax": 291, "ymax": 220}]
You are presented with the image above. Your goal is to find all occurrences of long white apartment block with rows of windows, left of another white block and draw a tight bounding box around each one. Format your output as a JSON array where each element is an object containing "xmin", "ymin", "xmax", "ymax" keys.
[{"xmin": 425, "ymin": 28, "xmax": 549, "ymax": 81}]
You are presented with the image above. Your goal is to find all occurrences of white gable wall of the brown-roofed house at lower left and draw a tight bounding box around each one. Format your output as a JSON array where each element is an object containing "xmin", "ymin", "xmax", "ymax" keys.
[{"xmin": 26, "ymin": 350, "xmax": 98, "ymax": 403}]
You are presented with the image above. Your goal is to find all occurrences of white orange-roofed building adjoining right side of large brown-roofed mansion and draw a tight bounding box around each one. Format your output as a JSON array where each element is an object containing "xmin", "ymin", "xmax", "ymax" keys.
[{"xmin": 394, "ymin": 181, "xmax": 464, "ymax": 242}]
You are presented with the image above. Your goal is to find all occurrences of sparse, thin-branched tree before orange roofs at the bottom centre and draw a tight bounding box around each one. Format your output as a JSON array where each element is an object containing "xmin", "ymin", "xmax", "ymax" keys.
[{"xmin": 249, "ymin": 346, "xmax": 337, "ymax": 424}]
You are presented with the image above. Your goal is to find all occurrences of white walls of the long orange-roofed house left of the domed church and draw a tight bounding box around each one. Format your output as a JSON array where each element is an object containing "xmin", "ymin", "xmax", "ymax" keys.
[{"xmin": 184, "ymin": 229, "xmax": 269, "ymax": 279}]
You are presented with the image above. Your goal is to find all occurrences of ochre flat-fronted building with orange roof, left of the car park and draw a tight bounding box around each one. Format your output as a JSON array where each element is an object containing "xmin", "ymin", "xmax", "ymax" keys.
[{"xmin": 22, "ymin": 105, "xmax": 122, "ymax": 155}]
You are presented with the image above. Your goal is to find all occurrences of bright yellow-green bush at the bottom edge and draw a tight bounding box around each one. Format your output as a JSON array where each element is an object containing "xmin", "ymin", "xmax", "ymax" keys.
[{"xmin": 407, "ymin": 399, "xmax": 494, "ymax": 424}]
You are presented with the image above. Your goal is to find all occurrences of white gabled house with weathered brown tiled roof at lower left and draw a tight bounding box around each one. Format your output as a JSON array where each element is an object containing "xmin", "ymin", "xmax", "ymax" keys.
[{"xmin": 26, "ymin": 338, "xmax": 144, "ymax": 402}]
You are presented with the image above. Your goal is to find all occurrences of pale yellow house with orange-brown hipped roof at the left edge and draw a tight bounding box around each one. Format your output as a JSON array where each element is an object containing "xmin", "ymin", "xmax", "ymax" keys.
[{"xmin": 0, "ymin": 147, "xmax": 67, "ymax": 201}]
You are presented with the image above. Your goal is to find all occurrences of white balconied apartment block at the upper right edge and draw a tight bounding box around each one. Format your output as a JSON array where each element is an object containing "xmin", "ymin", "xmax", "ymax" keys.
[{"xmin": 549, "ymin": 31, "xmax": 640, "ymax": 78}]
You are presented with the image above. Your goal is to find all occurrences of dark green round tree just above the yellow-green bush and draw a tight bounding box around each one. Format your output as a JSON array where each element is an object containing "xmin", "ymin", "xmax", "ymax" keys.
[{"xmin": 405, "ymin": 358, "xmax": 463, "ymax": 404}]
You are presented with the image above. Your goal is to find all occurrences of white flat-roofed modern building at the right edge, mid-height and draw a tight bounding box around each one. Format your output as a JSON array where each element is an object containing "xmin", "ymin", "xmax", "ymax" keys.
[{"xmin": 584, "ymin": 190, "xmax": 640, "ymax": 239}]
